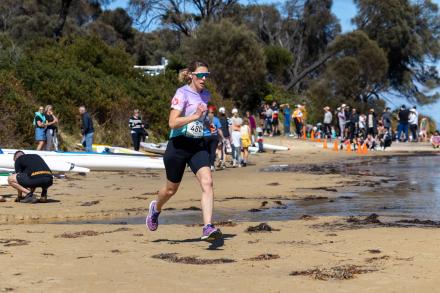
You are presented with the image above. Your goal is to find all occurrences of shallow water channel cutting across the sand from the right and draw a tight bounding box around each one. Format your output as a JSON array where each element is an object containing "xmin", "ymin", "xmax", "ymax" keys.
[{"xmin": 55, "ymin": 156, "xmax": 440, "ymax": 224}]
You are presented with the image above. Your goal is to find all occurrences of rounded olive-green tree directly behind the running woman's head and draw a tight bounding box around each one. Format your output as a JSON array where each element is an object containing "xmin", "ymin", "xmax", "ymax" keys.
[{"xmin": 183, "ymin": 20, "xmax": 266, "ymax": 107}]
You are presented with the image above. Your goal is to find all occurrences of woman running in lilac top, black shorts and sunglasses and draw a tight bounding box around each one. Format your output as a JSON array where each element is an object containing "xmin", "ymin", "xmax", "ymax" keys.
[{"xmin": 146, "ymin": 62, "xmax": 222, "ymax": 241}]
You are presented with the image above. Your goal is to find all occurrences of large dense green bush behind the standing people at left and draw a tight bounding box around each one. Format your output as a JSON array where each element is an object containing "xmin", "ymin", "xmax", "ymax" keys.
[{"xmin": 9, "ymin": 37, "xmax": 177, "ymax": 145}]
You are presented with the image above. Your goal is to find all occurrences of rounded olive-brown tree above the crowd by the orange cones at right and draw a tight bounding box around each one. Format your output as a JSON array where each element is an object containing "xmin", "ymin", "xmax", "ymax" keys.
[{"xmin": 309, "ymin": 31, "xmax": 388, "ymax": 116}]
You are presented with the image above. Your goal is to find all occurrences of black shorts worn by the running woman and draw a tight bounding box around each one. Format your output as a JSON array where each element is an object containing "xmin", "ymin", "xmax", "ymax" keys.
[{"xmin": 163, "ymin": 136, "xmax": 209, "ymax": 183}]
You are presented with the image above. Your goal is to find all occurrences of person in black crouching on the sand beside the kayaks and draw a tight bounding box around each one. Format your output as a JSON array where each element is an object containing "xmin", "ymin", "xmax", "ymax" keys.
[{"xmin": 8, "ymin": 151, "xmax": 53, "ymax": 203}]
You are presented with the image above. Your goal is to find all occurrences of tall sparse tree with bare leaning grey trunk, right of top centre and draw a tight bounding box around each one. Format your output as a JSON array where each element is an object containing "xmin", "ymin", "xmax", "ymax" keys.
[{"xmin": 242, "ymin": 0, "xmax": 340, "ymax": 92}]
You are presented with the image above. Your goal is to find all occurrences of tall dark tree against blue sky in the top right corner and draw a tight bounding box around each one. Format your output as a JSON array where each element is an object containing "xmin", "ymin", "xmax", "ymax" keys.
[{"xmin": 354, "ymin": 0, "xmax": 440, "ymax": 103}]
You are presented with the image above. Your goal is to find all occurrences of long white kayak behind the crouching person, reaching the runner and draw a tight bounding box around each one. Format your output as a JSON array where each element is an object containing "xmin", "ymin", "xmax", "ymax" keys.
[{"xmin": 0, "ymin": 149, "xmax": 165, "ymax": 171}]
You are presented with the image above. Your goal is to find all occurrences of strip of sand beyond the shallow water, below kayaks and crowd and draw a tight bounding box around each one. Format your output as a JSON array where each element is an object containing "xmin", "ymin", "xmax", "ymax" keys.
[{"xmin": 0, "ymin": 137, "xmax": 440, "ymax": 225}]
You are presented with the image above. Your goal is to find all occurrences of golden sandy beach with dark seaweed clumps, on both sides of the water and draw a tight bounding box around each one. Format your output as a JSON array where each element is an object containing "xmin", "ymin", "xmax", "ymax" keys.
[{"xmin": 0, "ymin": 138, "xmax": 440, "ymax": 292}]
